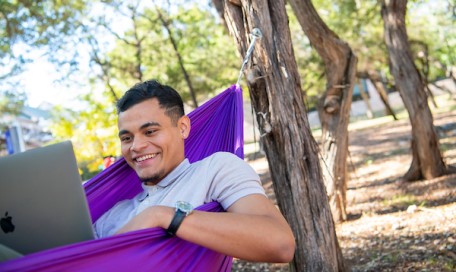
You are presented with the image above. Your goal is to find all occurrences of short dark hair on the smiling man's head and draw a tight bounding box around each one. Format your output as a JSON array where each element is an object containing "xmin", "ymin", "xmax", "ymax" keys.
[{"xmin": 116, "ymin": 80, "xmax": 185, "ymax": 123}]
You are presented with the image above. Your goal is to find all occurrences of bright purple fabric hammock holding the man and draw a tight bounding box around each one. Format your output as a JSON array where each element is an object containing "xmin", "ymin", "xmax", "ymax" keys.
[{"xmin": 0, "ymin": 85, "xmax": 244, "ymax": 271}]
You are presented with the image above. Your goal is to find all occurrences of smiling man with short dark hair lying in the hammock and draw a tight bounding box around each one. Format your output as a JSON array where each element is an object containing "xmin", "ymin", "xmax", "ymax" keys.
[{"xmin": 94, "ymin": 81, "xmax": 295, "ymax": 262}]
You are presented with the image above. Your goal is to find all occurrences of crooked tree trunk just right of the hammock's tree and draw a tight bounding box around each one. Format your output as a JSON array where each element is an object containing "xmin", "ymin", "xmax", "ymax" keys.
[{"xmin": 289, "ymin": 0, "xmax": 357, "ymax": 222}]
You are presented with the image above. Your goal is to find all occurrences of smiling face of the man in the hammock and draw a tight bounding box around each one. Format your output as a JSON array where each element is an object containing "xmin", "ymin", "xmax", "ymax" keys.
[{"xmin": 118, "ymin": 98, "xmax": 190, "ymax": 184}]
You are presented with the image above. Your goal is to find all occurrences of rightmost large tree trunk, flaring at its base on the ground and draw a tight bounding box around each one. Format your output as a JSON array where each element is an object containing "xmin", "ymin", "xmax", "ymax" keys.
[{"xmin": 381, "ymin": 0, "xmax": 446, "ymax": 183}]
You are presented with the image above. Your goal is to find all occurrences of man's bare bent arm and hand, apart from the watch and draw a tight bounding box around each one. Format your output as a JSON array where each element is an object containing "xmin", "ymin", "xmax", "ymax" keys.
[{"xmin": 118, "ymin": 194, "xmax": 295, "ymax": 263}]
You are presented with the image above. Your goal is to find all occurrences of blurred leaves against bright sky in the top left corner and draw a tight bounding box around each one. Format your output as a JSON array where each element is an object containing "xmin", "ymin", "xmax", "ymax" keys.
[{"xmin": 0, "ymin": 0, "xmax": 90, "ymax": 85}]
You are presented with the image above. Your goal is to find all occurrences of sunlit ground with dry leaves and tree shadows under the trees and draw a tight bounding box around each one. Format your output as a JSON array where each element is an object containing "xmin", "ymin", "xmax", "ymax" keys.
[{"xmin": 233, "ymin": 97, "xmax": 456, "ymax": 271}]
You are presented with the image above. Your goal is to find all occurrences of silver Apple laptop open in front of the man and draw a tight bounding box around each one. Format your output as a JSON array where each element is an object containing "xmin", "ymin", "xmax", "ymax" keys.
[{"xmin": 0, "ymin": 142, "xmax": 94, "ymax": 254}]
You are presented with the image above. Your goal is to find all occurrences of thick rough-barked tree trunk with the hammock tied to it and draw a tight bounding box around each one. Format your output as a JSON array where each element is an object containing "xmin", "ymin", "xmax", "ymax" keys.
[{"xmin": 219, "ymin": 0, "xmax": 345, "ymax": 271}]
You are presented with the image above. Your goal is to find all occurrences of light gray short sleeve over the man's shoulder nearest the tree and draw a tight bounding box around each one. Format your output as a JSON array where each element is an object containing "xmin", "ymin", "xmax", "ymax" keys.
[{"xmin": 208, "ymin": 152, "xmax": 266, "ymax": 210}]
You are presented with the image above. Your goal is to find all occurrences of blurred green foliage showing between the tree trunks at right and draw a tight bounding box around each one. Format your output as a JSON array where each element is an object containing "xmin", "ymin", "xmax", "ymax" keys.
[{"xmin": 288, "ymin": 0, "xmax": 456, "ymax": 109}]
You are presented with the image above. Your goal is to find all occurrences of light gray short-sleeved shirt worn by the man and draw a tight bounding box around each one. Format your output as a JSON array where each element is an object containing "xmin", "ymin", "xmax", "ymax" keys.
[{"xmin": 94, "ymin": 152, "xmax": 266, "ymax": 238}]
